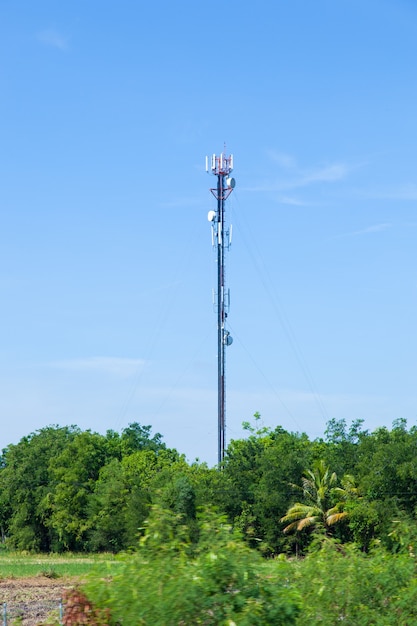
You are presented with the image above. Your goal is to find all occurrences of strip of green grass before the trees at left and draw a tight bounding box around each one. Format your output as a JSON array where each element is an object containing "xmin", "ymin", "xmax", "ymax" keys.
[{"xmin": 0, "ymin": 552, "xmax": 119, "ymax": 579}]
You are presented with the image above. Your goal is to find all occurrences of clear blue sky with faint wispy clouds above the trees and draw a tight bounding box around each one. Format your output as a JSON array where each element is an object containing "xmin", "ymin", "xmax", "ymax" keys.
[{"xmin": 0, "ymin": 0, "xmax": 417, "ymax": 465}]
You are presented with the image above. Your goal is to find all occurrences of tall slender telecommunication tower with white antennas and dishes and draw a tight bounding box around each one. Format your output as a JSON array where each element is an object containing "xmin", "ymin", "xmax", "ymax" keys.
[{"xmin": 206, "ymin": 153, "xmax": 236, "ymax": 467}]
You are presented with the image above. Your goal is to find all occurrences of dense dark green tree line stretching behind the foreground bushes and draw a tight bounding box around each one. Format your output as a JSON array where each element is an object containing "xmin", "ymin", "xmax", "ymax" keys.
[{"xmin": 0, "ymin": 415, "xmax": 417, "ymax": 556}]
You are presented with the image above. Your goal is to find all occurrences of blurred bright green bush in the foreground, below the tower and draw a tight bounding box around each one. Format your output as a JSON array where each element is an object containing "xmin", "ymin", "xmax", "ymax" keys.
[{"xmin": 86, "ymin": 509, "xmax": 300, "ymax": 626}]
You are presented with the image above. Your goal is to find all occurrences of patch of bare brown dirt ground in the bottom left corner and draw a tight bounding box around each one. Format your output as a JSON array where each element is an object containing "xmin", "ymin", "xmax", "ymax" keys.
[{"xmin": 0, "ymin": 576, "xmax": 75, "ymax": 626}]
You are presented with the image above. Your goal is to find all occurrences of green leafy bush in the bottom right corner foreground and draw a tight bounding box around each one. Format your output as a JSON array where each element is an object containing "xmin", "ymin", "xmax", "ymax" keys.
[{"xmin": 292, "ymin": 541, "xmax": 417, "ymax": 626}]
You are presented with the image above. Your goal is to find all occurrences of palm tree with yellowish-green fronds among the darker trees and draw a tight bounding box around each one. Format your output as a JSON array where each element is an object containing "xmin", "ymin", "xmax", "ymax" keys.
[{"xmin": 281, "ymin": 460, "xmax": 357, "ymax": 534}]
